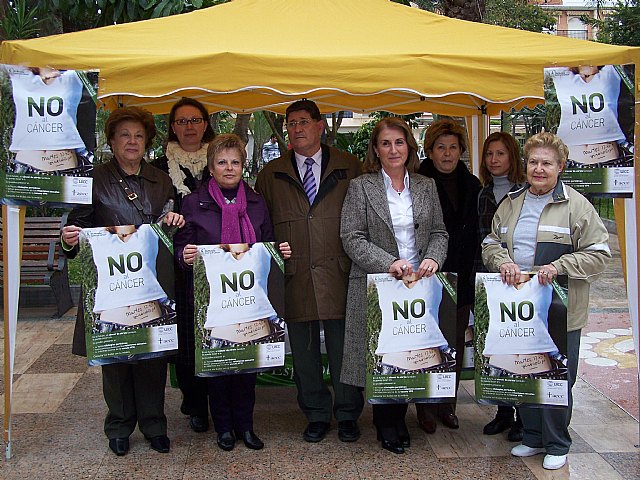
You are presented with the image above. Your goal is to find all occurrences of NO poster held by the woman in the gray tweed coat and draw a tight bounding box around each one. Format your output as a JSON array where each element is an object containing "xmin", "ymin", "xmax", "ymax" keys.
[{"xmin": 366, "ymin": 273, "xmax": 456, "ymax": 403}]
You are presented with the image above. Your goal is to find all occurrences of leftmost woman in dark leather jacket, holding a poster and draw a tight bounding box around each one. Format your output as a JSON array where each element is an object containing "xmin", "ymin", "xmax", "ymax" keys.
[{"xmin": 61, "ymin": 107, "xmax": 184, "ymax": 456}]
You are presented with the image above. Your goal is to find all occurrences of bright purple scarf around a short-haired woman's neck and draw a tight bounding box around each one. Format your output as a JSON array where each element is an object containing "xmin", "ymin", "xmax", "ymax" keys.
[{"xmin": 209, "ymin": 178, "xmax": 256, "ymax": 243}]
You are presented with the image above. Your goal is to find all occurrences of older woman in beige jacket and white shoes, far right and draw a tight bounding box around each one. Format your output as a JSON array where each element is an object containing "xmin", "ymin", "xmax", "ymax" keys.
[{"xmin": 482, "ymin": 133, "xmax": 611, "ymax": 470}]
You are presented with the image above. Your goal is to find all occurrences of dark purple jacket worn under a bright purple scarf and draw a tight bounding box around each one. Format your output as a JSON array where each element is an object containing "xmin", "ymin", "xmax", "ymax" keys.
[{"xmin": 173, "ymin": 178, "xmax": 273, "ymax": 270}]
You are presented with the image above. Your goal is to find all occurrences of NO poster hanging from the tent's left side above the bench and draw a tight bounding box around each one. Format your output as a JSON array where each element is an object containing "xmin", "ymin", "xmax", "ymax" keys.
[{"xmin": 0, "ymin": 64, "xmax": 98, "ymax": 207}]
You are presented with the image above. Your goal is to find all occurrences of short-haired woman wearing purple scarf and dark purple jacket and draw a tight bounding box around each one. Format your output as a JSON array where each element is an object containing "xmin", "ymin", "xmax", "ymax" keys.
[{"xmin": 174, "ymin": 134, "xmax": 291, "ymax": 451}]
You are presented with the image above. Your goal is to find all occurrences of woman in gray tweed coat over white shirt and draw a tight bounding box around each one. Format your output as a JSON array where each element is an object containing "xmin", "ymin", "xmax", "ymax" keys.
[{"xmin": 340, "ymin": 117, "xmax": 448, "ymax": 453}]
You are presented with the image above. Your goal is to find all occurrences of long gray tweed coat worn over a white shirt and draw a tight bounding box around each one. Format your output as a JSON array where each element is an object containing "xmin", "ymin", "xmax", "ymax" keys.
[{"xmin": 340, "ymin": 173, "xmax": 449, "ymax": 387}]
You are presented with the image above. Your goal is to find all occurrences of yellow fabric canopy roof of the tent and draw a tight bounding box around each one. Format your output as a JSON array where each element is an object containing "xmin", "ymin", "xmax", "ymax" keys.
[{"xmin": 0, "ymin": 0, "xmax": 640, "ymax": 115}]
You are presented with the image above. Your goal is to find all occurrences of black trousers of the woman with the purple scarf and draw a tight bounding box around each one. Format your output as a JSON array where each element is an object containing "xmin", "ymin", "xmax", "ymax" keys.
[{"xmin": 207, "ymin": 373, "xmax": 257, "ymax": 433}]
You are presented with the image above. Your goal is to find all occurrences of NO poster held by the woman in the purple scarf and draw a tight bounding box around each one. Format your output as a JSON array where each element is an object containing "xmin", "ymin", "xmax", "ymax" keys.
[{"xmin": 193, "ymin": 242, "xmax": 285, "ymax": 376}]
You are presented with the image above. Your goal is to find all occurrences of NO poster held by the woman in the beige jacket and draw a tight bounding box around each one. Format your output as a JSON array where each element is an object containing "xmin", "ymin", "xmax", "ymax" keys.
[{"xmin": 475, "ymin": 273, "xmax": 568, "ymax": 406}]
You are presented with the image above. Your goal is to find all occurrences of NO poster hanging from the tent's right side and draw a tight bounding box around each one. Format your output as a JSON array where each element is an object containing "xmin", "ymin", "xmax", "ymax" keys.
[{"xmin": 544, "ymin": 65, "xmax": 635, "ymax": 197}]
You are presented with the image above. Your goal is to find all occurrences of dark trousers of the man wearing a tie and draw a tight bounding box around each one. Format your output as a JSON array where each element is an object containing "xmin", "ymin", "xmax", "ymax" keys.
[{"xmin": 287, "ymin": 319, "xmax": 364, "ymax": 423}]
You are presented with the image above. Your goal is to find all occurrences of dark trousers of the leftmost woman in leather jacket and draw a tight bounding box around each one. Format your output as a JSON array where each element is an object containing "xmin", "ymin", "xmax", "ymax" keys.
[{"xmin": 102, "ymin": 358, "xmax": 167, "ymax": 439}]
